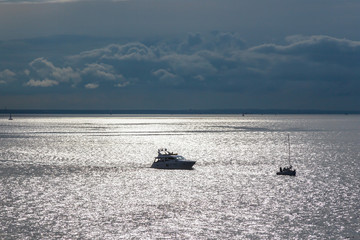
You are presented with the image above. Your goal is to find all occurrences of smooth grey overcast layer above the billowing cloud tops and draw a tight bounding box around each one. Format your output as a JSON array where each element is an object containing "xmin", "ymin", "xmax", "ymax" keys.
[{"xmin": 0, "ymin": 0, "xmax": 360, "ymax": 45}]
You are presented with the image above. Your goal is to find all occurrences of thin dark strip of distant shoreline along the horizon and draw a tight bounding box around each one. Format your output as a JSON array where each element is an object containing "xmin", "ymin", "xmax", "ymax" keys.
[{"xmin": 0, "ymin": 109, "xmax": 360, "ymax": 115}]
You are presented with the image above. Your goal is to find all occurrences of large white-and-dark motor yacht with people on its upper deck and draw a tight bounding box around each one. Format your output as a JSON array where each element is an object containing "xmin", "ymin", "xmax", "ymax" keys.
[{"xmin": 151, "ymin": 148, "xmax": 196, "ymax": 169}]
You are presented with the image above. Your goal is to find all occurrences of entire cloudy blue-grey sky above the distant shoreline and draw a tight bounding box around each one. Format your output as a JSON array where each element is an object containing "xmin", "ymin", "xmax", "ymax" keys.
[{"xmin": 0, "ymin": 0, "xmax": 360, "ymax": 111}]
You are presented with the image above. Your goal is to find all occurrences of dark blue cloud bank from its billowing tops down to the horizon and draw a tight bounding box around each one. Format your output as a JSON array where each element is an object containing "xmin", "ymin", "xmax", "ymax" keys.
[{"xmin": 0, "ymin": 32, "xmax": 360, "ymax": 111}]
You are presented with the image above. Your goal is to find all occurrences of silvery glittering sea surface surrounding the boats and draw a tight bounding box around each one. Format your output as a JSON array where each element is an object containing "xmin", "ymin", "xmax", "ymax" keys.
[{"xmin": 0, "ymin": 115, "xmax": 360, "ymax": 239}]
